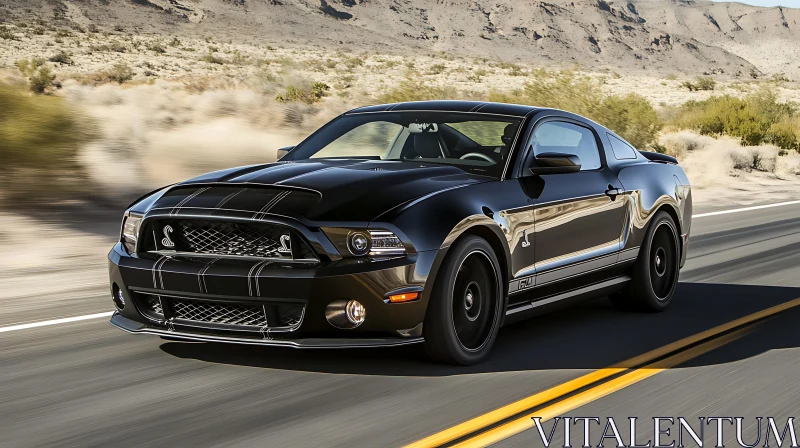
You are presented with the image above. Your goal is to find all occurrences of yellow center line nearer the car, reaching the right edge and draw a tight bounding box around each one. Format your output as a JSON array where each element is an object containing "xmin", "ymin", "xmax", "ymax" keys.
[{"xmin": 406, "ymin": 298, "xmax": 800, "ymax": 448}]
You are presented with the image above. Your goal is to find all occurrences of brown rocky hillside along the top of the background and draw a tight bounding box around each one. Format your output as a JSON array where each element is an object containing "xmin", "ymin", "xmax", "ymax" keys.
[{"xmin": 0, "ymin": 0, "xmax": 800, "ymax": 79}]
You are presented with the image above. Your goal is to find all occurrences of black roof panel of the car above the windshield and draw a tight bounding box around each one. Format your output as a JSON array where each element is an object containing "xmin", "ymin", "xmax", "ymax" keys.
[{"xmin": 347, "ymin": 100, "xmax": 542, "ymax": 117}]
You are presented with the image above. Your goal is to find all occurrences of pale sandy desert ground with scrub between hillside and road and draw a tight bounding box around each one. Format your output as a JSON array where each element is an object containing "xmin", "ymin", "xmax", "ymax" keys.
[{"xmin": 0, "ymin": 21, "xmax": 800, "ymax": 201}]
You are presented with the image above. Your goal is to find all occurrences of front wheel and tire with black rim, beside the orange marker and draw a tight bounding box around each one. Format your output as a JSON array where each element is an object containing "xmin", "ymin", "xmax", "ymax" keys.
[{"xmin": 422, "ymin": 236, "xmax": 505, "ymax": 365}]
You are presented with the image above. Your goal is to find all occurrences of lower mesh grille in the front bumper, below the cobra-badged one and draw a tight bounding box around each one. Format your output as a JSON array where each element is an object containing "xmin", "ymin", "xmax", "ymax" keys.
[{"xmin": 135, "ymin": 293, "xmax": 305, "ymax": 330}]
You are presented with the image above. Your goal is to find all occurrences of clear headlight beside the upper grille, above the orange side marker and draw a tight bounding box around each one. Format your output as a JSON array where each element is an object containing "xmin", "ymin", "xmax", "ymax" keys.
[{"xmin": 322, "ymin": 227, "xmax": 406, "ymax": 257}]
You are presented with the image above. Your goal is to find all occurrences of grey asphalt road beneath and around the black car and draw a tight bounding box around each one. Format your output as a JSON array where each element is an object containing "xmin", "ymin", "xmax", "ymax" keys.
[{"xmin": 0, "ymin": 205, "xmax": 800, "ymax": 447}]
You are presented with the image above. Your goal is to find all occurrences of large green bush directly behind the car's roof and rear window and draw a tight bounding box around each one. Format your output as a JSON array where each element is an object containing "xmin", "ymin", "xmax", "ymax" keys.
[{"xmin": 489, "ymin": 69, "xmax": 661, "ymax": 149}]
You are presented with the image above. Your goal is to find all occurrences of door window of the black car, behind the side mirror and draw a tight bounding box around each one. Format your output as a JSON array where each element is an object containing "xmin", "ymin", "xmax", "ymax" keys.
[{"xmin": 530, "ymin": 121, "xmax": 600, "ymax": 171}]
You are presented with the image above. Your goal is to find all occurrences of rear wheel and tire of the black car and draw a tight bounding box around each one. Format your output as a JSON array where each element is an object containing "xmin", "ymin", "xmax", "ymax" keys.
[{"xmin": 610, "ymin": 212, "xmax": 681, "ymax": 312}]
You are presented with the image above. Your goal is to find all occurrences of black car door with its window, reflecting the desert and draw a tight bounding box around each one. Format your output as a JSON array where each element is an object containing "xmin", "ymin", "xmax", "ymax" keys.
[{"xmin": 511, "ymin": 117, "xmax": 626, "ymax": 292}]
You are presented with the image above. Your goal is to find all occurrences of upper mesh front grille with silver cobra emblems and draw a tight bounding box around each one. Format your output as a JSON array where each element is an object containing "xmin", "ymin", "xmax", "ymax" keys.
[{"xmin": 144, "ymin": 219, "xmax": 317, "ymax": 260}]
